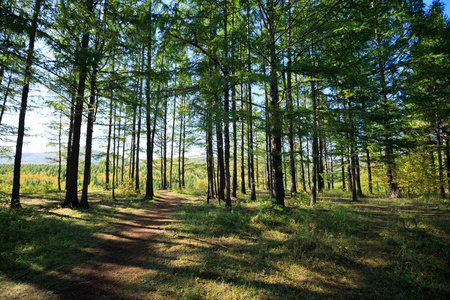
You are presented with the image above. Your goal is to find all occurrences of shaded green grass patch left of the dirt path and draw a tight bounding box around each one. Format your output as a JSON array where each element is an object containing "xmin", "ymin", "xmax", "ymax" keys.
[{"xmin": 0, "ymin": 191, "xmax": 156, "ymax": 299}]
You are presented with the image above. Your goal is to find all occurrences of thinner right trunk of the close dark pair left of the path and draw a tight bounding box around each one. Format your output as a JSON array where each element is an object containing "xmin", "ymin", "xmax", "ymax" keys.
[{"xmin": 80, "ymin": 69, "xmax": 97, "ymax": 208}]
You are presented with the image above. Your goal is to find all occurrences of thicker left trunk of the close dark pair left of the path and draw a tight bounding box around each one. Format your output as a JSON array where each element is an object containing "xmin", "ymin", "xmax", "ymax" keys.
[{"xmin": 63, "ymin": 0, "xmax": 94, "ymax": 206}]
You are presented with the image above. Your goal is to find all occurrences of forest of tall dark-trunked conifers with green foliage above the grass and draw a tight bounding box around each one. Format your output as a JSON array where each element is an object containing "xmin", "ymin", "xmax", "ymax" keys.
[{"xmin": 0, "ymin": 0, "xmax": 450, "ymax": 208}]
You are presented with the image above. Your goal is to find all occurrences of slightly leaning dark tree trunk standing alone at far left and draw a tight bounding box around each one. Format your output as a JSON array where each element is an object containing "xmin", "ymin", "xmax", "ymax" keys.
[{"xmin": 11, "ymin": 0, "xmax": 42, "ymax": 208}]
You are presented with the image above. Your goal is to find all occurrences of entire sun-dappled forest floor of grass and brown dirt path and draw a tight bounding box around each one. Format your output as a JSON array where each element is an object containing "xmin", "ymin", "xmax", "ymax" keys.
[{"xmin": 0, "ymin": 191, "xmax": 450, "ymax": 300}]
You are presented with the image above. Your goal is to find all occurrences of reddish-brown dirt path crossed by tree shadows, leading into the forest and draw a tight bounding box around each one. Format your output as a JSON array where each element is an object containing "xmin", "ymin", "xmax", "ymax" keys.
[{"xmin": 52, "ymin": 191, "xmax": 180, "ymax": 300}]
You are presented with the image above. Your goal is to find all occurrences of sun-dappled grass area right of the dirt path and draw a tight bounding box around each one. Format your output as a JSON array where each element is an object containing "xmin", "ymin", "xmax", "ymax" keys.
[{"xmin": 147, "ymin": 194, "xmax": 450, "ymax": 299}]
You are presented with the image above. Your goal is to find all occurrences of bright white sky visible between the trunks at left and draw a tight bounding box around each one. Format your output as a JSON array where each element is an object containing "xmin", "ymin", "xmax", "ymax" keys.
[{"xmin": 0, "ymin": 0, "xmax": 450, "ymax": 153}]
